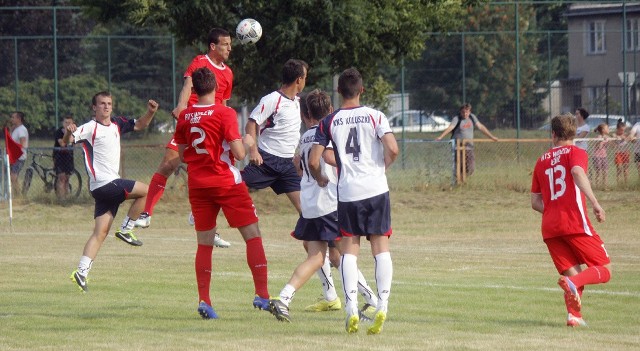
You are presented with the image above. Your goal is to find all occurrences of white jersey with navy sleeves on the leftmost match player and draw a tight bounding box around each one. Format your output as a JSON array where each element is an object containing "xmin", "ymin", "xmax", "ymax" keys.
[{"xmin": 73, "ymin": 117, "xmax": 136, "ymax": 190}]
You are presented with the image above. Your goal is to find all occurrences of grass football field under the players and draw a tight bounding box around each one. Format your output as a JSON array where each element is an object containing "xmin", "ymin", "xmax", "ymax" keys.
[{"xmin": 0, "ymin": 188, "xmax": 640, "ymax": 350}]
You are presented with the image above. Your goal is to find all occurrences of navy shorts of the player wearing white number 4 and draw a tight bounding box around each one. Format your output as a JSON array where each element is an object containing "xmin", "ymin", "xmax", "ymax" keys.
[{"xmin": 338, "ymin": 191, "xmax": 391, "ymax": 237}]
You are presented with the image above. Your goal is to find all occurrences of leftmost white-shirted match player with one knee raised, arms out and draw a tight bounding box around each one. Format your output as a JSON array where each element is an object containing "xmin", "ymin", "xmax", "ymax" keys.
[{"xmin": 62, "ymin": 91, "xmax": 158, "ymax": 292}]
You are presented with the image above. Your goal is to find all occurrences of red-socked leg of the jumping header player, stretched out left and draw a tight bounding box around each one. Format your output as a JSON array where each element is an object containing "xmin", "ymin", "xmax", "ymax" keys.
[{"xmin": 136, "ymin": 145, "xmax": 181, "ymax": 228}]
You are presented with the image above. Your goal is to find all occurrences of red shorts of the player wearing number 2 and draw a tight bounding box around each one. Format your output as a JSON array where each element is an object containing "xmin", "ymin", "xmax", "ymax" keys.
[{"xmin": 189, "ymin": 182, "xmax": 258, "ymax": 232}]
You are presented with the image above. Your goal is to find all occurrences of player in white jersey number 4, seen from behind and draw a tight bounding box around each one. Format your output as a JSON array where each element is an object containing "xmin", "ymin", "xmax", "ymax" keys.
[{"xmin": 309, "ymin": 68, "xmax": 399, "ymax": 334}]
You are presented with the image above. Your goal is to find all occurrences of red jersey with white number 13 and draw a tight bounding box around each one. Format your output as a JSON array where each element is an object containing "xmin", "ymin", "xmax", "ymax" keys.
[{"xmin": 531, "ymin": 145, "xmax": 597, "ymax": 239}]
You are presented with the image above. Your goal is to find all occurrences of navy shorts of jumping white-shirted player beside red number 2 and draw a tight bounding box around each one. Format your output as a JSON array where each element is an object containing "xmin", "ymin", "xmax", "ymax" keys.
[{"xmin": 242, "ymin": 149, "xmax": 300, "ymax": 195}]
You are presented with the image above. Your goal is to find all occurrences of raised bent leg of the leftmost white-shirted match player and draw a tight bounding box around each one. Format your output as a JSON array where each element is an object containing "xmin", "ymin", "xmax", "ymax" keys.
[{"xmin": 114, "ymin": 179, "xmax": 149, "ymax": 246}]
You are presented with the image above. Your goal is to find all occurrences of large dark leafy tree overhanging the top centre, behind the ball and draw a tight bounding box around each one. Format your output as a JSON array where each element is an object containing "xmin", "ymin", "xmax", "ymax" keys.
[{"xmin": 75, "ymin": 0, "xmax": 478, "ymax": 105}]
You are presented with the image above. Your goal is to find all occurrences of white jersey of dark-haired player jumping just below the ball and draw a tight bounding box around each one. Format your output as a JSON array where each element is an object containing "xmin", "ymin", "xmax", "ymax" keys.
[{"xmin": 249, "ymin": 91, "xmax": 302, "ymax": 158}]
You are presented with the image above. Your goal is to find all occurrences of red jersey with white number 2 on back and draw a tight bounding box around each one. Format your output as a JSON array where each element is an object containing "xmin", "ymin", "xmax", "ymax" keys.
[{"xmin": 174, "ymin": 104, "xmax": 242, "ymax": 189}]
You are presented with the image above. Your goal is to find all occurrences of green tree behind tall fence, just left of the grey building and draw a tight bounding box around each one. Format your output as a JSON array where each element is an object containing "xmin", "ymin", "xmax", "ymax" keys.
[{"xmin": 407, "ymin": 4, "xmax": 559, "ymax": 126}]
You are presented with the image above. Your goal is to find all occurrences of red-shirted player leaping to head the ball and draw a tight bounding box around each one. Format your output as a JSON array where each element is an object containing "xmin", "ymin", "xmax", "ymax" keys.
[{"xmin": 136, "ymin": 28, "xmax": 233, "ymax": 247}]
